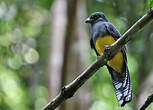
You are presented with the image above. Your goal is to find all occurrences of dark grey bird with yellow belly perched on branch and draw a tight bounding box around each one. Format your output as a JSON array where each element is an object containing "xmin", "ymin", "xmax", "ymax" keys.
[{"xmin": 85, "ymin": 12, "xmax": 132, "ymax": 107}]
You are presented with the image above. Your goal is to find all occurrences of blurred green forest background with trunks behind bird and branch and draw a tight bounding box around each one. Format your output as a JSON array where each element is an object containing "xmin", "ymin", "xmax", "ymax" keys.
[{"xmin": 0, "ymin": 0, "xmax": 153, "ymax": 110}]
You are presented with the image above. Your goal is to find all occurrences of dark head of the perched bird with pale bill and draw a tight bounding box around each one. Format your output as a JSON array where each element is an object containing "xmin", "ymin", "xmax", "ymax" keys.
[{"xmin": 85, "ymin": 12, "xmax": 108, "ymax": 24}]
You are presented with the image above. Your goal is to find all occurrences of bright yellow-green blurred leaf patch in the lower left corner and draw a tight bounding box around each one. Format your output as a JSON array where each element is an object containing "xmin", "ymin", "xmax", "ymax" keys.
[{"xmin": 0, "ymin": 65, "xmax": 28, "ymax": 110}]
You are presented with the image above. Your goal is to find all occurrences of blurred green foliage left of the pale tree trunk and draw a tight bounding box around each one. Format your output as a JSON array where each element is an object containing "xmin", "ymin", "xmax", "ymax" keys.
[{"xmin": 0, "ymin": 0, "xmax": 52, "ymax": 110}]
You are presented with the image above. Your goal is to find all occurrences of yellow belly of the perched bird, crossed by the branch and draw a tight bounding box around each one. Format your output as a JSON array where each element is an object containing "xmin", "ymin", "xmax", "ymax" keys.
[{"xmin": 95, "ymin": 36, "xmax": 123, "ymax": 73}]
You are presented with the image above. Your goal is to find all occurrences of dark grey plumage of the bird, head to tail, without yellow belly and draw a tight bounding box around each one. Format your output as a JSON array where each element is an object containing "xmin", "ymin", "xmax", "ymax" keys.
[{"xmin": 85, "ymin": 12, "xmax": 132, "ymax": 106}]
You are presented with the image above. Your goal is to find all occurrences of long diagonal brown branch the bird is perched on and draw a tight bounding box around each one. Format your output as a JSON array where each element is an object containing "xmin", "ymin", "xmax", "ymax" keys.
[{"xmin": 42, "ymin": 8, "xmax": 153, "ymax": 110}]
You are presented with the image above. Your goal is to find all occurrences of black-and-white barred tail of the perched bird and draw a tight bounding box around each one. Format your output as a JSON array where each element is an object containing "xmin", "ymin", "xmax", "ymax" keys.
[{"xmin": 107, "ymin": 63, "xmax": 132, "ymax": 106}]
